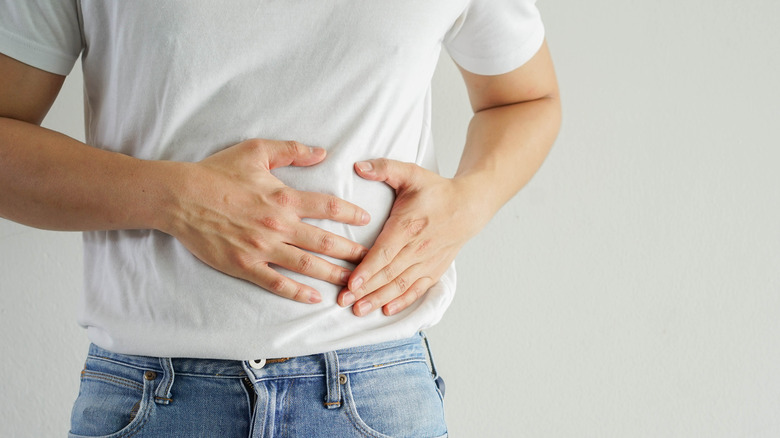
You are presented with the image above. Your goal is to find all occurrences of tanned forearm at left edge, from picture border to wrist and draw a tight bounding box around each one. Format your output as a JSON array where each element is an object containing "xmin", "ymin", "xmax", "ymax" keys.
[{"xmin": 0, "ymin": 118, "xmax": 177, "ymax": 231}]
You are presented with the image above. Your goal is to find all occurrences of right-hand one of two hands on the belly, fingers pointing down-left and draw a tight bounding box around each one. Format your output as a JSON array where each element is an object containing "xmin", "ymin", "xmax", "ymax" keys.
[{"xmin": 338, "ymin": 159, "xmax": 484, "ymax": 316}]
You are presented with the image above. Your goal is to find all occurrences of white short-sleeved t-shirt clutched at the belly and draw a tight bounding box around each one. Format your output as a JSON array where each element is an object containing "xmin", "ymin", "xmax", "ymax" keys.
[{"xmin": 0, "ymin": 0, "xmax": 544, "ymax": 359}]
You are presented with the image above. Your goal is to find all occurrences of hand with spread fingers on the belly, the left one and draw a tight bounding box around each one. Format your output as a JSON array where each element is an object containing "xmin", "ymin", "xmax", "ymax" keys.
[{"xmin": 163, "ymin": 139, "xmax": 370, "ymax": 303}]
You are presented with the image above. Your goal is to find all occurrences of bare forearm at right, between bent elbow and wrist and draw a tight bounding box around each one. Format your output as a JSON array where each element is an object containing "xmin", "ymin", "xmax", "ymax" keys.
[{"xmin": 453, "ymin": 95, "xmax": 561, "ymax": 226}]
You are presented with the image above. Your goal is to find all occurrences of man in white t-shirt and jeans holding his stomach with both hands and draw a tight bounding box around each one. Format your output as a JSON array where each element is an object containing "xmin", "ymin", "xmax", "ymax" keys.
[{"xmin": 0, "ymin": 0, "xmax": 560, "ymax": 437}]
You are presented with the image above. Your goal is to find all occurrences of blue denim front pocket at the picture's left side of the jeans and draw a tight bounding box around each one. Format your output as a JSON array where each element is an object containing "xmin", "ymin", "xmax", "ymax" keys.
[{"xmin": 68, "ymin": 358, "xmax": 156, "ymax": 438}]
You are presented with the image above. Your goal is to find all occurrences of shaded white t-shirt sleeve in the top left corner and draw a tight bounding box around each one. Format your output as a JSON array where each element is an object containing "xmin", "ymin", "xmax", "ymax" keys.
[{"xmin": 0, "ymin": 0, "xmax": 82, "ymax": 75}]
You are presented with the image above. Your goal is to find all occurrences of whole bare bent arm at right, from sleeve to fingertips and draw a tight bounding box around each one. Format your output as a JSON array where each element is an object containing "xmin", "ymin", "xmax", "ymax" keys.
[{"xmin": 339, "ymin": 43, "xmax": 561, "ymax": 316}]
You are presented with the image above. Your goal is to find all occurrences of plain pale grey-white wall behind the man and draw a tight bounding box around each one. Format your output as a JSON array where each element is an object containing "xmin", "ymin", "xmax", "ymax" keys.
[{"xmin": 0, "ymin": 0, "xmax": 780, "ymax": 437}]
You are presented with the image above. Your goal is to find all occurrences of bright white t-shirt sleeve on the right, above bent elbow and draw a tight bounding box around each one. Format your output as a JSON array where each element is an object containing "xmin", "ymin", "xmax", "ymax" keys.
[{"xmin": 444, "ymin": 0, "xmax": 544, "ymax": 75}]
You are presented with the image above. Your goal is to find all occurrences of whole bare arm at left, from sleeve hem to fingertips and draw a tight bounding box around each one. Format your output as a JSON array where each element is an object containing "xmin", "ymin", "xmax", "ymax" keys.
[{"xmin": 0, "ymin": 55, "xmax": 369, "ymax": 302}]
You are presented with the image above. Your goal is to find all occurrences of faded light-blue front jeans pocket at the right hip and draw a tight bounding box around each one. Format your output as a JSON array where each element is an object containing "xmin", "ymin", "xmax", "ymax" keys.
[{"xmin": 342, "ymin": 361, "xmax": 447, "ymax": 438}]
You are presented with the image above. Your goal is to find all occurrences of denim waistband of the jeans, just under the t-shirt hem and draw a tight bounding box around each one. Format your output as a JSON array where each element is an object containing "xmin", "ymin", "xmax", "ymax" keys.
[{"xmin": 89, "ymin": 334, "xmax": 427, "ymax": 378}]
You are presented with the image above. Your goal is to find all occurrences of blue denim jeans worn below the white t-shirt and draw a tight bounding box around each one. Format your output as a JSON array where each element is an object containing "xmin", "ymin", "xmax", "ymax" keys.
[{"xmin": 69, "ymin": 335, "xmax": 447, "ymax": 438}]
